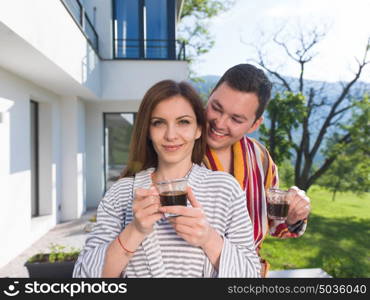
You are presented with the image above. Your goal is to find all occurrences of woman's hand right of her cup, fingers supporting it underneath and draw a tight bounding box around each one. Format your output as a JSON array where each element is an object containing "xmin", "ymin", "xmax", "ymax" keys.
[{"xmin": 159, "ymin": 187, "xmax": 214, "ymax": 248}]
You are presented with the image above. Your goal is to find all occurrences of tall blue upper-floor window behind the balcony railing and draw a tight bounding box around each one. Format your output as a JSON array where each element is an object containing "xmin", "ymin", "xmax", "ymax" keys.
[{"xmin": 113, "ymin": 0, "xmax": 176, "ymax": 59}]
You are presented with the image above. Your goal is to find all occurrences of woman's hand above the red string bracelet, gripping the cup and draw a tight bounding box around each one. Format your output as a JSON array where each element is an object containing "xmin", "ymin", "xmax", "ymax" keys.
[{"xmin": 132, "ymin": 187, "xmax": 163, "ymax": 235}]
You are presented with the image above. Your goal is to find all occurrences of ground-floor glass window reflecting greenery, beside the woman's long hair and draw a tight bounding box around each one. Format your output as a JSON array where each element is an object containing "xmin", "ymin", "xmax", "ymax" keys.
[{"xmin": 104, "ymin": 113, "xmax": 135, "ymax": 190}]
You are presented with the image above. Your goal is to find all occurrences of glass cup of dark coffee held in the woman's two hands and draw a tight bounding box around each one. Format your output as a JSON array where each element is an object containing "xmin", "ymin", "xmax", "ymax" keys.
[{"xmin": 155, "ymin": 178, "xmax": 188, "ymax": 217}]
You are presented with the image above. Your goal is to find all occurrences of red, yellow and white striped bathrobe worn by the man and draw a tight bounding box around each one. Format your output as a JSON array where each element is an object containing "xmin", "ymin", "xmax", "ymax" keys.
[{"xmin": 204, "ymin": 136, "xmax": 307, "ymax": 250}]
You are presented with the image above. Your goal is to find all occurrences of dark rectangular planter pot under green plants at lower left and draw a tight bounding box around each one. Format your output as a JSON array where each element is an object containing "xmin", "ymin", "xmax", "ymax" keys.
[{"xmin": 25, "ymin": 261, "xmax": 76, "ymax": 278}]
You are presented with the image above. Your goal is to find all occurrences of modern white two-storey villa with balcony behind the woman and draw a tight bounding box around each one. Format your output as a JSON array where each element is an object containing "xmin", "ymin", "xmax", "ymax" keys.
[{"xmin": 0, "ymin": 0, "xmax": 188, "ymax": 267}]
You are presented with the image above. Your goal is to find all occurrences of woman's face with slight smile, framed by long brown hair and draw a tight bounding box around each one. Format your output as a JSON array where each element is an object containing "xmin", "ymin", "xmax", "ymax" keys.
[{"xmin": 149, "ymin": 96, "xmax": 201, "ymax": 165}]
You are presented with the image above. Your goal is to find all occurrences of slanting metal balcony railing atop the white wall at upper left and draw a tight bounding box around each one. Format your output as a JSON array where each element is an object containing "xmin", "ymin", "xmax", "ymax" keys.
[{"xmin": 61, "ymin": 0, "xmax": 99, "ymax": 53}]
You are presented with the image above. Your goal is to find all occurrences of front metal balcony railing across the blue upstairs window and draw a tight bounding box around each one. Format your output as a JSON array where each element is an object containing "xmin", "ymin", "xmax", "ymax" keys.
[{"xmin": 114, "ymin": 39, "xmax": 186, "ymax": 60}]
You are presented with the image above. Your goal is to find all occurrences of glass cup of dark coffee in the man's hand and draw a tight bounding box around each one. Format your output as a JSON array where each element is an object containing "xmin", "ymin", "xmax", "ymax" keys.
[{"xmin": 266, "ymin": 188, "xmax": 290, "ymax": 220}]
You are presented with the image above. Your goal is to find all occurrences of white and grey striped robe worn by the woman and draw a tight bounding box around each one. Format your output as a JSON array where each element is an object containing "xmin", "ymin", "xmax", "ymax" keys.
[{"xmin": 73, "ymin": 165, "xmax": 260, "ymax": 277}]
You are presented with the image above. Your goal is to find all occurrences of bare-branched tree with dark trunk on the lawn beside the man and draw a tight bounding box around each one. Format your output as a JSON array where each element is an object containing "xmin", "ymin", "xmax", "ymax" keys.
[{"xmin": 247, "ymin": 28, "xmax": 370, "ymax": 190}]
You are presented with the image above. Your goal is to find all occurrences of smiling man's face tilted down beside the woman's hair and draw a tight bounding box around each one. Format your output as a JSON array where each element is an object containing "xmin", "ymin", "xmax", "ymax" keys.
[{"xmin": 206, "ymin": 82, "xmax": 263, "ymax": 151}]
